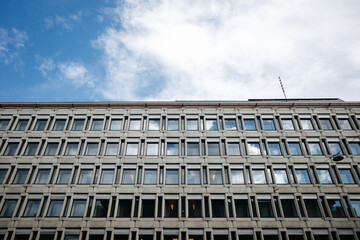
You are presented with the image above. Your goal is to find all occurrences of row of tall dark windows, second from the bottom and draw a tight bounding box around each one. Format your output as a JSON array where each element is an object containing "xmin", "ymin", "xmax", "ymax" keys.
[{"xmin": 0, "ymin": 194, "xmax": 360, "ymax": 218}]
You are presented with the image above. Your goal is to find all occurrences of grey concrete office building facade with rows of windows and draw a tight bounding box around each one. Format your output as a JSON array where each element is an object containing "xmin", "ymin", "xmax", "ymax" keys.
[{"xmin": 0, "ymin": 99, "xmax": 360, "ymax": 240}]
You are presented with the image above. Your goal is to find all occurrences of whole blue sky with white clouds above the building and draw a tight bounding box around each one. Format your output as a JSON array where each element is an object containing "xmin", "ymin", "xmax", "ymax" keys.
[{"xmin": 0, "ymin": 0, "xmax": 360, "ymax": 102}]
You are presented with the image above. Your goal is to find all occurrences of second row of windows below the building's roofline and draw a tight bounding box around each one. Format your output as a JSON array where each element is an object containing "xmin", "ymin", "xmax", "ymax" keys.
[{"xmin": 0, "ymin": 137, "xmax": 360, "ymax": 156}]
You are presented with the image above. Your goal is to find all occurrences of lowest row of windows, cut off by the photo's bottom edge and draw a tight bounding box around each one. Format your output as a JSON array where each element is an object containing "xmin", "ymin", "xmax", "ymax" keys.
[{"xmin": 0, "ymin": 229, "xmax": 360, "ymax": 240}]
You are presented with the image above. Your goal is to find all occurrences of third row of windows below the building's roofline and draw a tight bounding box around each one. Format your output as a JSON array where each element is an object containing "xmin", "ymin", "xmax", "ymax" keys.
[{"xmin": 0, "ymin": 164, "xmax": 360, "ymax": 188}]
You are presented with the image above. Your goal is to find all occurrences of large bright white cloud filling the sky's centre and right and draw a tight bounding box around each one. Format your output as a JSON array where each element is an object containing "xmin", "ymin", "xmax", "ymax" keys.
[{"xmin": 93, "ymin": 0, "xmax": 360, "ymax": 100}]
